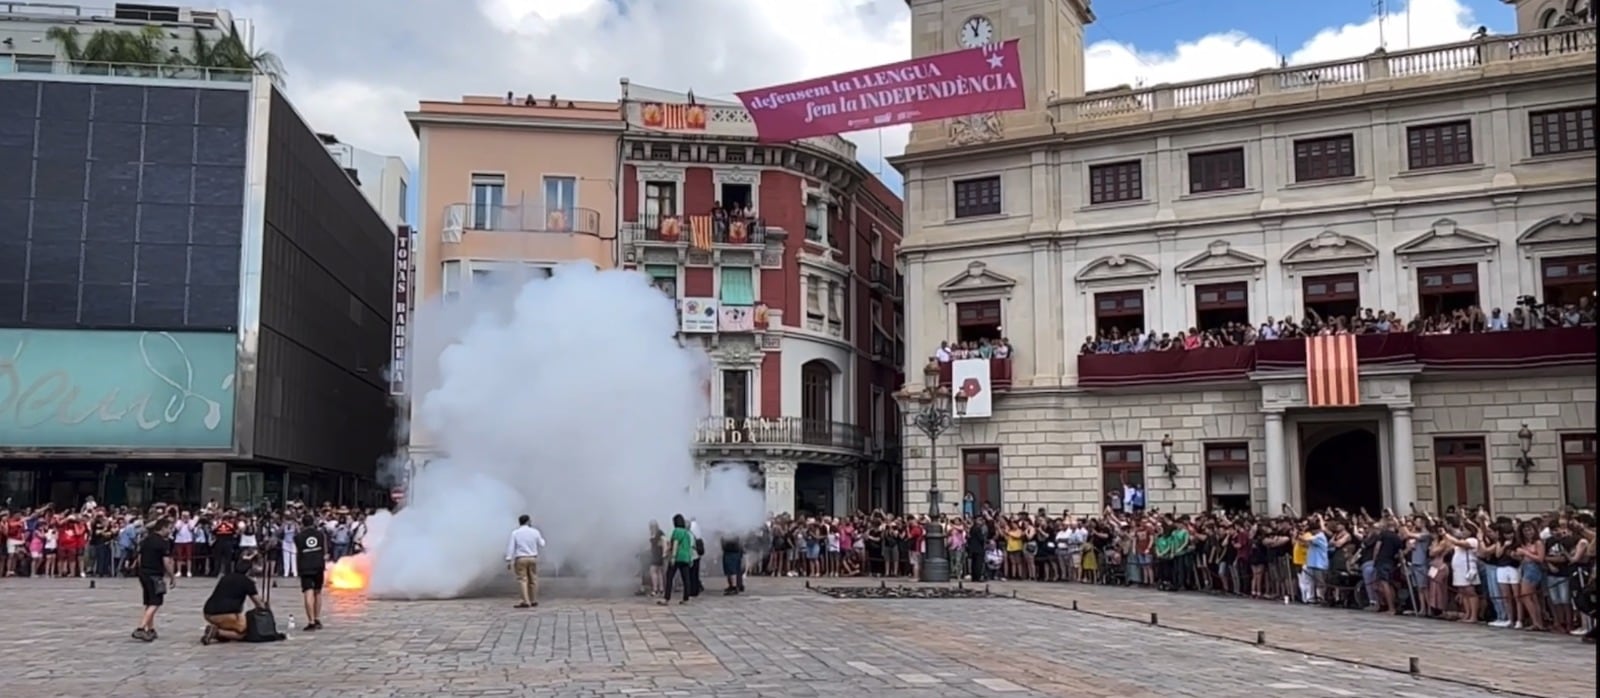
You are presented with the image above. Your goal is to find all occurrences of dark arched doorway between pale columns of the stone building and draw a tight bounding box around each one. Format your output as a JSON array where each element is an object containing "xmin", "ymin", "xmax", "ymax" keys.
[{"xmin": 1301, "ymin": 427, "xmax": 1384, "ymax": 515}]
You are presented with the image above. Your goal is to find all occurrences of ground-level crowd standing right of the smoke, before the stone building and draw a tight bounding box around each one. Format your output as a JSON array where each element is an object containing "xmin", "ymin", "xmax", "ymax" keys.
[{"xmin": 746, "ymin": 506, "xmax": 1597, "ymax": 642}]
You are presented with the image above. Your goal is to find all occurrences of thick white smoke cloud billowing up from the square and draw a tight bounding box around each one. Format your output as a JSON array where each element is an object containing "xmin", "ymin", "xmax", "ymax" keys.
[{"xmin": 357, "ymin": 263, "xmax": 763, "ymax": 599}]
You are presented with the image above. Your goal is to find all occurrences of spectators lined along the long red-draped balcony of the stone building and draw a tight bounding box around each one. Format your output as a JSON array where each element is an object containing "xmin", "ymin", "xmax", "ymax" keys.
[{"xmin": 1078, "ymin": 296, "xmax": 1595, "ymax": 354}]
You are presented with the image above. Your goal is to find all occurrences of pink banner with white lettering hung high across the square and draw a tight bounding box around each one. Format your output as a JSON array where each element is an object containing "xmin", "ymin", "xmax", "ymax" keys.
[{"xmin": 739, "ymin": 38, "xmax": 1027, "ymax": 141}]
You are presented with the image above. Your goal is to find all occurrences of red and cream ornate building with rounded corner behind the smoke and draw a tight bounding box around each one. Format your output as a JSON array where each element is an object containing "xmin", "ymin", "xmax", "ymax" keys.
[{"xmin": 618, "ymin": 80, "xmax": 904, "ymax": 514}]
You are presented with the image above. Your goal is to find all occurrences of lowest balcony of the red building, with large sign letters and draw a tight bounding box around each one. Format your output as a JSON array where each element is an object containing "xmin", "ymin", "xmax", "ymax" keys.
[{"xmin": 694, "ymin": 416, "xmax": 867, "ymax": 464}]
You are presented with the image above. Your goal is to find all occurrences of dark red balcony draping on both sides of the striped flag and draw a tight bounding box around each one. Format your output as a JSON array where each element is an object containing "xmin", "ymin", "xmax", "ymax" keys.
[{"xmin": 1075, "ymin": 327, "xmax": 1595, "ymax": 389}]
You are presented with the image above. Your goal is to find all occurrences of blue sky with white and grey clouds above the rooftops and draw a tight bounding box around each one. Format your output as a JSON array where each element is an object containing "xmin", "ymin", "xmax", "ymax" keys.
[{"xmin": 221, "ymin": 0, "xmax": 1515, "ymax": 195}]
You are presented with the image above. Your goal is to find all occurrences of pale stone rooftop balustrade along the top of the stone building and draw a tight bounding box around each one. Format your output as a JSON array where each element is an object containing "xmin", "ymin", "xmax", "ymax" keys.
[{"xmin": 1050, "ymin": 24, "xmax": 1595, "ymax": 131}]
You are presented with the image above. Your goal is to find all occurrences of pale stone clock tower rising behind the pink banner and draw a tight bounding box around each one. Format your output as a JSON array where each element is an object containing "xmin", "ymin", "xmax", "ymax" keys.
[{"xmin": 906, "ymin": 0, "xmax": 1094, "ymax": 152}]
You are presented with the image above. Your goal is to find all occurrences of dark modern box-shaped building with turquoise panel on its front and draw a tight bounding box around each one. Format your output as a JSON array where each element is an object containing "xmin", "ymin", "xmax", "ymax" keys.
[{"xmin": 0, "ymin": 75, "xmax": 395, "ymax": 506}]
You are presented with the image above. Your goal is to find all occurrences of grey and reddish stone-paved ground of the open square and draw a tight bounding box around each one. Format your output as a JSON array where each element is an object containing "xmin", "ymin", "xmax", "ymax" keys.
[{"xmin": 0, "ymin": 580, "xmax": 1595, "ymax": 698}]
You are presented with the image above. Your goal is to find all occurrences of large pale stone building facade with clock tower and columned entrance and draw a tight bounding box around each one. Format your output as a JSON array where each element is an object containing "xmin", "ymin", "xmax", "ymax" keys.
[{"xmin": 896, "ymin": 0, "xmax": 1595, "ymax": 514}]
